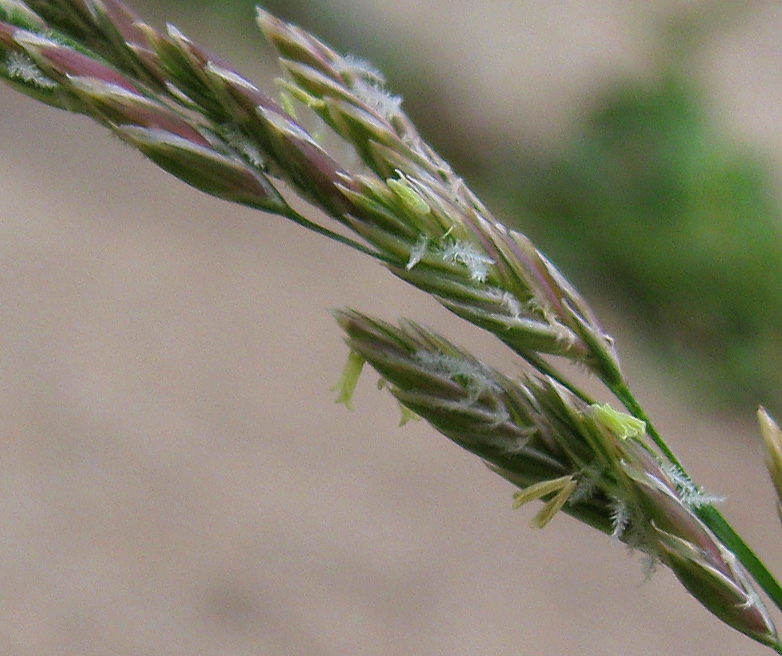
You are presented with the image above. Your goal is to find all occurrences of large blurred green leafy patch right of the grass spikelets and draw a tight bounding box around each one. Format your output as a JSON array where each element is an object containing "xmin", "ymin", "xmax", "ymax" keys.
[{"xmin": 515, "ymin": 73, "xmax": 782, "ymax": 408}]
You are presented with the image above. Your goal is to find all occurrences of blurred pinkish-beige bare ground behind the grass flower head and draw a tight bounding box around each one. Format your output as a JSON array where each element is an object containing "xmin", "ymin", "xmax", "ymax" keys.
[{"xmin": 0, "ymin": 0, "xmax": 782, "ymax": 656}]
